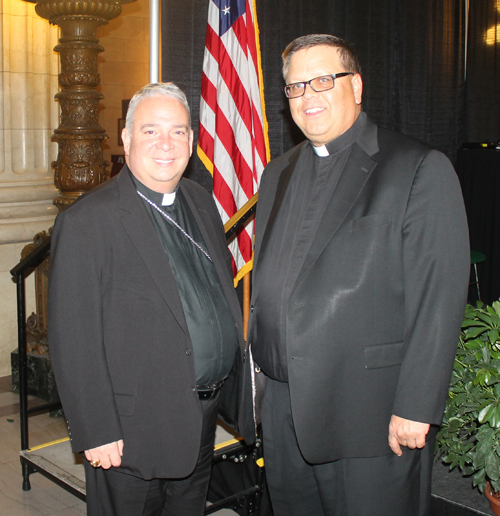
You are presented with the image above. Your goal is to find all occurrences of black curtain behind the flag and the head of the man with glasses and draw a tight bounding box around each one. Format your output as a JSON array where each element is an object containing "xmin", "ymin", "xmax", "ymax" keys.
[{"xmin": 162, "ymin": 0, "xmax": 464, "ymax": 189}]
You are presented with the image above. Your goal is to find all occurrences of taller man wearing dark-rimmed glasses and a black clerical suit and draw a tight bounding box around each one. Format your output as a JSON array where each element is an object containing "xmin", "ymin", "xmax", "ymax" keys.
[{"xmin": 247, "ymin": 35, "xmax": 470, "ymax": 516}]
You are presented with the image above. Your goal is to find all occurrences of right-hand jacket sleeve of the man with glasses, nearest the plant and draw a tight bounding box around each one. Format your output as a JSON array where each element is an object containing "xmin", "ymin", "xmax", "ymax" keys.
[{"xmin": 393, "ymin": 151, "xmax": 470, "ymax": 424}]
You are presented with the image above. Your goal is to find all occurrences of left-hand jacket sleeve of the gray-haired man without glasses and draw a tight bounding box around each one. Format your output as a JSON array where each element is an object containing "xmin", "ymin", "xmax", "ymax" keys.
[{"xmin": 48, "ymin": 212, "xmax": 123, "ymax": 452}]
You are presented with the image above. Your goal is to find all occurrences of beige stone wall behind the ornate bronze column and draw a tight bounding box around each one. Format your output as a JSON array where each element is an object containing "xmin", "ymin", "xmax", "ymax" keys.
[{"xmin": 0, "ymin": 0, "xmax": 153, "ymax": 376}]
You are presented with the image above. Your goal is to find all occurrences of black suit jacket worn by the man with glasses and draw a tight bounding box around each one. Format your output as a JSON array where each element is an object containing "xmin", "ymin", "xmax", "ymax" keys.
[{"xmin": 245, "ymin": 117, "xmax": 470, "ymax": 463}]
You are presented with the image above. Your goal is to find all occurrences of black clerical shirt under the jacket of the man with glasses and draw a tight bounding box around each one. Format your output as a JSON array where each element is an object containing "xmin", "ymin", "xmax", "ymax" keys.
[{"xmin": 252, "ymin": 113, "xmax": 366, "ymax": 382}]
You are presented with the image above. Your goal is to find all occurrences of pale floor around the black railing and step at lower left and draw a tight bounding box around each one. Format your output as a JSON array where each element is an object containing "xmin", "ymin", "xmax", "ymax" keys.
[{"xmin": 0, "ymin": 377, "xmax": 236, "ymax": 516}]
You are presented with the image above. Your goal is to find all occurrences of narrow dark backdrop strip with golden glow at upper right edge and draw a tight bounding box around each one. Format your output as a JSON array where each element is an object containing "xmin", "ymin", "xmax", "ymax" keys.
[{"xmin": 465, "ymin": 0, "xmax": 500, "ymax": 143}]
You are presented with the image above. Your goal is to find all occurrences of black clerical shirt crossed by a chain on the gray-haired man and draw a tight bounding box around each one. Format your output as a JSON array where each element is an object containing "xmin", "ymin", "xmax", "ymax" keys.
[{"xmin": 132, "ymin": 176, "xmax": 238, "ymax": 385}]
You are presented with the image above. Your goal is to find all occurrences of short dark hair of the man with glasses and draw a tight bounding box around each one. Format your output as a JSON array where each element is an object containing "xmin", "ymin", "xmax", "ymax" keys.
[{"xmin": 281, "ymin": 34, "xmax": 361, "ymax": 82}]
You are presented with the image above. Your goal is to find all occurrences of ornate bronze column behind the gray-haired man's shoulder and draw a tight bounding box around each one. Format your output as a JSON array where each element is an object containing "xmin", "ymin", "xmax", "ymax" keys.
[{"xmin": 36, "ymin": 0, "xmax": 126, "ymax": 211}]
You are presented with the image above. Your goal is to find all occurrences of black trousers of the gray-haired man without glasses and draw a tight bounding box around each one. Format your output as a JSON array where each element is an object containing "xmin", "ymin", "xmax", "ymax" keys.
[{"xmin": 83, "ymin": 395, "xmax": 219, "ymax": 516}]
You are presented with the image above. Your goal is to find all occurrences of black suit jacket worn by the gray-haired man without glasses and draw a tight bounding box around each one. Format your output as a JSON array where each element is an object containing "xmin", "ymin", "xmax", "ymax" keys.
[{"xmin": 49, "ymin": 167, "xmax": 243, "ymax": 478}]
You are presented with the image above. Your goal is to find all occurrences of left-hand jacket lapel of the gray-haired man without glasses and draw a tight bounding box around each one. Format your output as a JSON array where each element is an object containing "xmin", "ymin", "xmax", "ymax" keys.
[{"xmin": 118, "ymin": 166, "xmax": 189, "ymax": 336}]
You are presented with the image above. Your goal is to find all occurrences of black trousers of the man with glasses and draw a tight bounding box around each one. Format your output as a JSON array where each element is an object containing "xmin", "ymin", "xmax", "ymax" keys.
[{"xmin": 262, "ymin": 378, "xmax": 436, "ymax": 516}]
